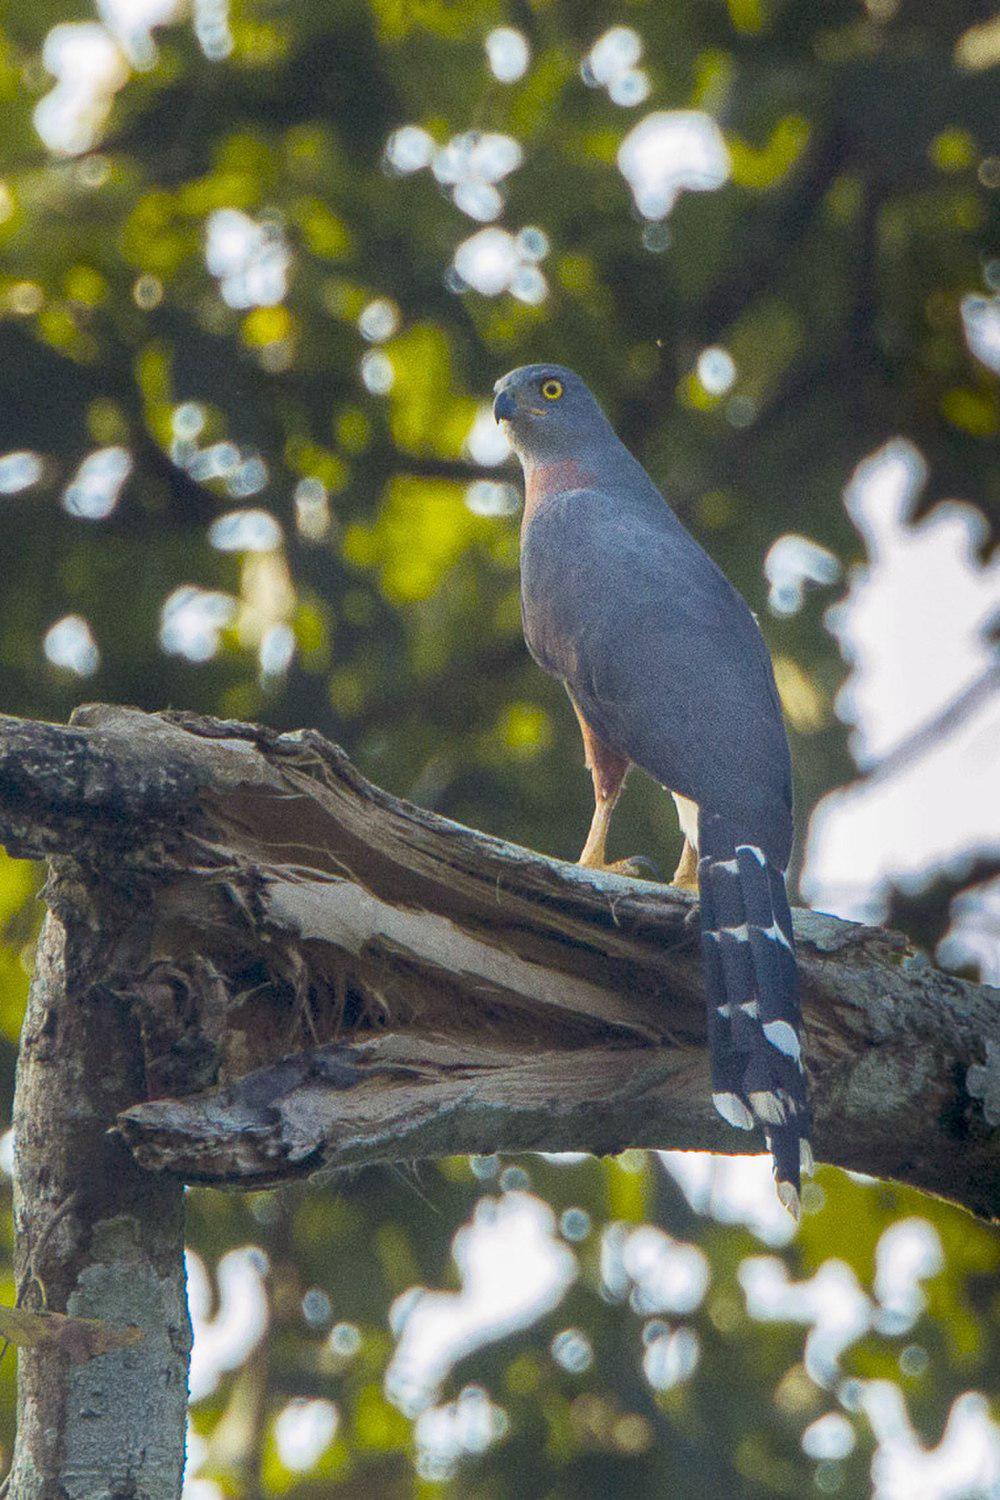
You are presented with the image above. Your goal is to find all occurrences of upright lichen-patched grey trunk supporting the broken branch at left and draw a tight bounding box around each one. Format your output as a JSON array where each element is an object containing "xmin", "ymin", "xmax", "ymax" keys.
[{"xmin": 9, "ymin": 894, "xmax": 190, "ymax": 1500}]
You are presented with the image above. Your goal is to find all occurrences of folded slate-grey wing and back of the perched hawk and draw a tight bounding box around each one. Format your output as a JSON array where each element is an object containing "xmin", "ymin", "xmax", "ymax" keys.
[{"xmin": 522, "ymin": 483, "xmax": 792, "ymax": 869}]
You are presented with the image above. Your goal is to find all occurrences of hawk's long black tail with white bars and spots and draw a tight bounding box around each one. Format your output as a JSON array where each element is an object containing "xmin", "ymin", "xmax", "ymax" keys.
[{"xmin": 699, "ymin": 813, "xmax": 813, "ymax": 1218}]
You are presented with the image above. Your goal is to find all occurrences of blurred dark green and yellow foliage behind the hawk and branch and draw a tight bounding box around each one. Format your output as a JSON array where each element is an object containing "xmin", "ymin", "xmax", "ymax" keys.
[{"xmin": 0, "ymin": 0, "xmax": 1000, "ymax": 1500}]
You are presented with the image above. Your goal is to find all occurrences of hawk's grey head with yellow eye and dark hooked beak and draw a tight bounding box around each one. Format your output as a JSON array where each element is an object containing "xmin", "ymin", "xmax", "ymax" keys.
[{"xmin": 493, "ymin": 365, "xmax": 609, "ymax": 462}]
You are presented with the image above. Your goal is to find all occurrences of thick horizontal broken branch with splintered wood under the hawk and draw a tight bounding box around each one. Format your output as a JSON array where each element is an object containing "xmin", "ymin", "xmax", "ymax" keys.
[{"xmin": 0, "ymin": 707, "xmax": 1000, "ymax": 1215}]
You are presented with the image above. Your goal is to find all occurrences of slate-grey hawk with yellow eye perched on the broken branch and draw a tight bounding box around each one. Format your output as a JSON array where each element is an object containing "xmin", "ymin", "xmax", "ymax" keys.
[{"xmin": 493, "ymin": 365, "xmax": 813, "ymax": 1217}]
